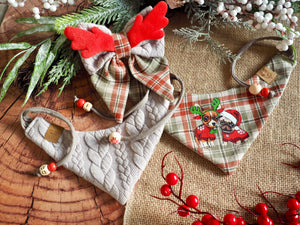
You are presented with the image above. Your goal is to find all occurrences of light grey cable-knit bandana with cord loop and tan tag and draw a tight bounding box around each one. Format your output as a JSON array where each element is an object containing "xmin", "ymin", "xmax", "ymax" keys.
[{"xmin": 21, "ymin": 74, "xmax": 183, "ymax": 204}]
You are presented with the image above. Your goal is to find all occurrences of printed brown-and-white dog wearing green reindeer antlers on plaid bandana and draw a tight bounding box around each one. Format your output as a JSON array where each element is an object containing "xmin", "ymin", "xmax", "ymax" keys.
[{"xmin": 190, "ymin": 98, "xmax": 220, "ymax": 148}]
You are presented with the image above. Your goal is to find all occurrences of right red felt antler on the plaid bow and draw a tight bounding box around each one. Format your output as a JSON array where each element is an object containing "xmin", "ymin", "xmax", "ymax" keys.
[{"xmin": 127, "ymin": 1, "xmax": 169, "ymax": 48}]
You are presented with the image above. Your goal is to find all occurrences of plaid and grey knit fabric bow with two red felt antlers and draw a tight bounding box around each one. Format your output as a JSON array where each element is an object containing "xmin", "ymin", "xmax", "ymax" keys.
[{"xmin": 65, "ymin": 2, "xmax": 174, "ymax": 123}]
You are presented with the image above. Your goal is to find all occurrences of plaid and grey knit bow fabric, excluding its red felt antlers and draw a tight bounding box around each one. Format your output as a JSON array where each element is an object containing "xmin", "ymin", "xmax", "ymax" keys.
[{"xmin": 66, "ymin": 3, "xmax": 174, "ymax": 123}]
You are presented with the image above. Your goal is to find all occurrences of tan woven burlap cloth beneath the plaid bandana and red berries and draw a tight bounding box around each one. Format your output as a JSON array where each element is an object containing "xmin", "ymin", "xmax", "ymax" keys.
[{"xmin": 124, "ymin": 13, "xmax": 300, "ymax": 225}]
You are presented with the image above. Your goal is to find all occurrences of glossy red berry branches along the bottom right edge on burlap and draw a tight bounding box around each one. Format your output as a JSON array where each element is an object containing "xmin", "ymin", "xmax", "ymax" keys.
[{"xmin": 152, "ymin": 152, "xmax": 300, "ymax": 225}]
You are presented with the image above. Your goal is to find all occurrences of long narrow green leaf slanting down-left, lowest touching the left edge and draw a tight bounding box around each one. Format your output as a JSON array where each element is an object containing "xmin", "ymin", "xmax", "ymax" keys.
[{"xmin": 0, "ymin": 46, "xmax": 37, "ymax": 102}]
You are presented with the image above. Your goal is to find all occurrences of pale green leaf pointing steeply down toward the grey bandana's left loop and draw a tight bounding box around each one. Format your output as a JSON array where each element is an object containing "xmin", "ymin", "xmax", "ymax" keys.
[{"xmin": 23, "ymin": 38, "xmax": 51, "ymax": 105}]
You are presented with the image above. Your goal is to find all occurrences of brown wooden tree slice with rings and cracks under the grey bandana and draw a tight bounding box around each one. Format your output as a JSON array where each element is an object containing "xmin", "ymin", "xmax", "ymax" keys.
[{"xmin": 0, "ymin": 1, "xmax": 125, "ymax": 225}]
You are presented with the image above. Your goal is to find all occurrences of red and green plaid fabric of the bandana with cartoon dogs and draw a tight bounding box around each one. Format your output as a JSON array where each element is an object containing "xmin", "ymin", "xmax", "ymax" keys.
[{"xmin": 165, "ymin": 51, "xmax": 295, "ymax": 175}]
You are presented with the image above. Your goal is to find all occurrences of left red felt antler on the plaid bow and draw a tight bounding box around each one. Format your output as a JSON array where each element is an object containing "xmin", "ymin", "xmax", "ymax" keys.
[{"xmin": 65, "ymin": 27, "xmax": 115, "ymax": 58}]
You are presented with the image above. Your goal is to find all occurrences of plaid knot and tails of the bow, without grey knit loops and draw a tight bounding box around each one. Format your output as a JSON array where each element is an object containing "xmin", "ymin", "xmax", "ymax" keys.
[{"xmin": 91, "ymin": 33, "xmax": 174, "ymax": 123}]
